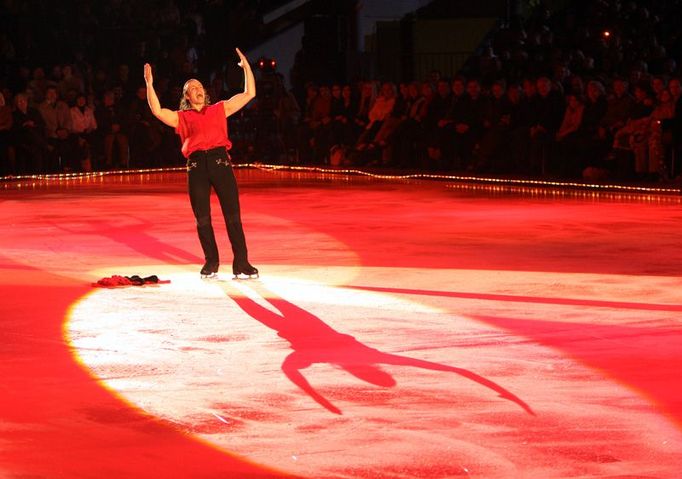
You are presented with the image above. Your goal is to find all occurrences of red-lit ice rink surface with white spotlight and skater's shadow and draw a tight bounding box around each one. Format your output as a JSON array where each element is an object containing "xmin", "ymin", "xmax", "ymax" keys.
[{"xmin": 0, "ymin": 165, "xmax": 682, "ymax": 479}]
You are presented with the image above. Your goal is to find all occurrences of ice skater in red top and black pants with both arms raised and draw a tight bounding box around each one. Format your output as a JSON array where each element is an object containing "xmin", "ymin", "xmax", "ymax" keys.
[{"xmin": 144, "ymin": 48, "xmax": 258, "ymax": 278}]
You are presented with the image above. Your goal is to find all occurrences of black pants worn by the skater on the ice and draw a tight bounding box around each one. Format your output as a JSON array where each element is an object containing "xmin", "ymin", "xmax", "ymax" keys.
[{"xmin": 187, "ymin": 147, "xmax": 248, "ymax": 265}]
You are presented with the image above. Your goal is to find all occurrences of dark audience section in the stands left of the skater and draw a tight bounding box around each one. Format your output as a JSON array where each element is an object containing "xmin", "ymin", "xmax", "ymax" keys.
[{"xmin": 0, "ymin": 0, "xmax": 274, "ymax": 176}]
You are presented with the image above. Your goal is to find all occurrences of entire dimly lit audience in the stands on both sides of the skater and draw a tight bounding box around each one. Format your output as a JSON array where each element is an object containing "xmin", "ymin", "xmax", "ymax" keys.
[{"xmin": 0, "ymin": 0, "xmax": 682, "ymax": 181}]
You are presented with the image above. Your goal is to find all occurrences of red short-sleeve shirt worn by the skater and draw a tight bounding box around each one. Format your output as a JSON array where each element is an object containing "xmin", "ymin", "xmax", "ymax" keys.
[{"xmin": 175, "ymin": 102, "xmax": 232, "ymax": 158}]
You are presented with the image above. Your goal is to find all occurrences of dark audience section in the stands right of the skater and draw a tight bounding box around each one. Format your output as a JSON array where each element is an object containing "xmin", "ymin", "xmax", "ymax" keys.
[{"xmin": 289, "ymin": 0, "xmax": 682, "ymax": 181}]
